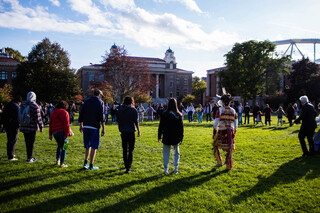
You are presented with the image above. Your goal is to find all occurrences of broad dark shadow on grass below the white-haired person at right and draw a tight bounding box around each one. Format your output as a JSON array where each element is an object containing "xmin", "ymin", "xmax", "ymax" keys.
[{"xmin": 231, "ymin": 156, "xmax": 320, "ymax": 203}]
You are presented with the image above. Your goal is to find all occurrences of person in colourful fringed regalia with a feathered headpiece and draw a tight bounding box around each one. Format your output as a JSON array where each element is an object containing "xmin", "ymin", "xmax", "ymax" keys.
[{"xmin": 212, "ymin": 94, "xmax": 238, "ymax": 170}]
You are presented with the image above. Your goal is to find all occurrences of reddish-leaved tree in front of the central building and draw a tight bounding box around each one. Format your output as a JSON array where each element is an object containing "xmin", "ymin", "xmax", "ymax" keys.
[{"xmin": 104, "ymin": 45, "xmax": 155, "ymax": 102}]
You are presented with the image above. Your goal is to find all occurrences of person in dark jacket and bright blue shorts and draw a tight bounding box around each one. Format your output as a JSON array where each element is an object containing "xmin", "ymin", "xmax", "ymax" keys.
[{"xmin": 79, "ymin": 89, "xmax": 105, "ymax": 170}]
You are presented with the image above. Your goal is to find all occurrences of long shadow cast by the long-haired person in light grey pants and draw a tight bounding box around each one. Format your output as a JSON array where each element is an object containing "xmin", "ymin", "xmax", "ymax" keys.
[{"xmin": 10, "ymin": 172, "xmax": 163, "ymax": 213}]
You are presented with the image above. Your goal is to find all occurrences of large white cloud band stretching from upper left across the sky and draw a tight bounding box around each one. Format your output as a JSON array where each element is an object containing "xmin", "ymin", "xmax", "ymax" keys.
[{"xmin": 0, "ymin": 0, "xmax": 240, "ymax": 50}]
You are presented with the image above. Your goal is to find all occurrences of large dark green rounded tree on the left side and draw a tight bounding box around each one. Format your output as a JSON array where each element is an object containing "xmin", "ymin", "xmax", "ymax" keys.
[{"xmin": 13, "ymin": 38, "xmax": 80, "ymax": 102}]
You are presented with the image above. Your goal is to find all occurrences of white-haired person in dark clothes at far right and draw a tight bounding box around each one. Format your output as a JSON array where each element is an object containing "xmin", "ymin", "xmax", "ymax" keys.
[{"xmin": 294, "ymin": 96, "xmax": 317, "ymax": 157}]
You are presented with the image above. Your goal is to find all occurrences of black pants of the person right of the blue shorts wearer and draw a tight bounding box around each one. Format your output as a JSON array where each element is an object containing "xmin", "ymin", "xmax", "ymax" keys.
[{"xmin": 121, "ymin": 132, "xmax": 135, "ymax": 169}]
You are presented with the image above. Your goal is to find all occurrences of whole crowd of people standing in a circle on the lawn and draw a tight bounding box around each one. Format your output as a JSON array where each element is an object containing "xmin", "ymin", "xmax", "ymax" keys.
[{"xmin": 2, "ymin": 89, "xmax": 320, "ymax": 174}]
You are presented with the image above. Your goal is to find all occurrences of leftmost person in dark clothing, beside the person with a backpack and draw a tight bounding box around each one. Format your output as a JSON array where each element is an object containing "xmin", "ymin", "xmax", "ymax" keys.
[{"xmin": 2, "ymin": 97, "xmax": 22, "ymax": 161}]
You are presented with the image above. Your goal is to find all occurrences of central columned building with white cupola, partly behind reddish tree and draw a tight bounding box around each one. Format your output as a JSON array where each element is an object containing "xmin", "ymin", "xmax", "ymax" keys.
[{"xmin": 77, "ymin": 45, "xmax": 193, "ymax": 102}]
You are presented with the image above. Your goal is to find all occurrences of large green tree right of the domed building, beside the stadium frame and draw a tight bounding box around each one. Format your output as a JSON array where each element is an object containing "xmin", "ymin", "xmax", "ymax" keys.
[{"xmin": 219, "ymin": 41, "xmax": 285, "ymax": 100}]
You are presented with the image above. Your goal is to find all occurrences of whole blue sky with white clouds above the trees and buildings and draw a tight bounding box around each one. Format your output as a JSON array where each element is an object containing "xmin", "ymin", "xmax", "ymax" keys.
[{"xmin": 0, "ymin": 0, "xmax": 320, "ymax": 77}]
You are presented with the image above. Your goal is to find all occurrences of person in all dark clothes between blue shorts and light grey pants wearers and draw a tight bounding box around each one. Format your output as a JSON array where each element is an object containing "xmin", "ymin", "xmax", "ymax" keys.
[{"xmin": 117, "ymin": 97, "xmax": 141, "ymax": 173}]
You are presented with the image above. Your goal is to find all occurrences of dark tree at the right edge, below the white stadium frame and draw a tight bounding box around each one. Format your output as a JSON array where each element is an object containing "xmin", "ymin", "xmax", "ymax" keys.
[{"xmin": 286, "ymin": 58, "xmax": 320, "ymax": 102}]
